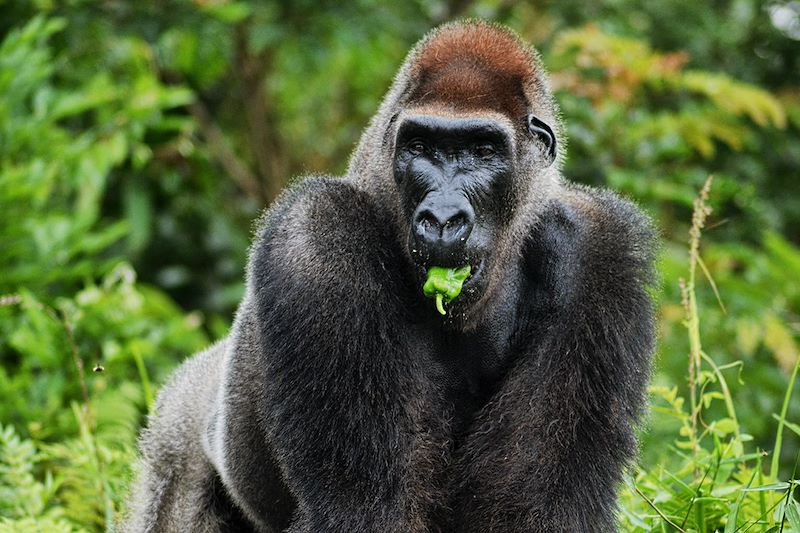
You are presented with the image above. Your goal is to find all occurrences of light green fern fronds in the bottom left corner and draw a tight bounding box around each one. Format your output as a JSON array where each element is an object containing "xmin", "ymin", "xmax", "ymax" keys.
[{"xmin": 0, "ymin": 406, "xmax": 136, "ymax": 532}]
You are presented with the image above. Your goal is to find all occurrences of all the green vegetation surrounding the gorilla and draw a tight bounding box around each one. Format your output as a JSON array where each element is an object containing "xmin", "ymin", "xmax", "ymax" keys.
[{"xmin": 0, "ymin": 0, "xmax": 800, "ymax": 533}]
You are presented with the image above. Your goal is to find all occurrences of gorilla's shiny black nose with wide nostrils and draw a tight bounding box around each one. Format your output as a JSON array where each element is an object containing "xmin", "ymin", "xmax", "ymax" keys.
[{"xmin": 413, "ymin": 195, "xmax": 475, "ymax": 252}]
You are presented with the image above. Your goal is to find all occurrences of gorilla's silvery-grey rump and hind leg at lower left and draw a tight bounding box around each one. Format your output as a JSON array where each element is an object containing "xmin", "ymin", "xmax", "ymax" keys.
[{"xmin": 121, "ymin": 340, "xmax": 256, "ymax": 533}]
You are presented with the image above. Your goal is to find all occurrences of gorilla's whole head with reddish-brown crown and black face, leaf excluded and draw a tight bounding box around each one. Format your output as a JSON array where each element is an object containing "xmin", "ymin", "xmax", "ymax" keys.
[{"xmin": 351, "ymin": 24, "xmax": 559, "ymax": 318}]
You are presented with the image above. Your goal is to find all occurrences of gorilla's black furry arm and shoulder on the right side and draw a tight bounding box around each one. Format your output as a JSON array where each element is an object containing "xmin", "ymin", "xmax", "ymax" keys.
[{"xmin": 455, "ymin": 188, "xmax": 654, "ymax": 533}]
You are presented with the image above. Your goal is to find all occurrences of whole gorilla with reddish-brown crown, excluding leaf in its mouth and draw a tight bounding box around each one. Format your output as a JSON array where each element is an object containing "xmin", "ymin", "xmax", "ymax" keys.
[{"xmin": 125, "ymin": 22, "xmax": 654, "ymax": 533}]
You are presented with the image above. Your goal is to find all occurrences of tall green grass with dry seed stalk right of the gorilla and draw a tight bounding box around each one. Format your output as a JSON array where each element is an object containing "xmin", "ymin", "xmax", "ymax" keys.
[{"xmin": 620, "ymin": 177, "xmax": 800, "ymax": 533}]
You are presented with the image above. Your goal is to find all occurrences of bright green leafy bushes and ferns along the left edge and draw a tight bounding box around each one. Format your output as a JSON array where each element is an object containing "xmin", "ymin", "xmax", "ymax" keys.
[{"xmin": 0, "ymin": 12, "xmax": 208, "ymax": 531}]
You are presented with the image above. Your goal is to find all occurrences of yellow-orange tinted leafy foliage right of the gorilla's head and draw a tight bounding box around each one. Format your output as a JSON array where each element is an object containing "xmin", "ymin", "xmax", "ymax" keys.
[{"xmin": 551, "ymin": 26, "xmax": 786, "ymax": 195}]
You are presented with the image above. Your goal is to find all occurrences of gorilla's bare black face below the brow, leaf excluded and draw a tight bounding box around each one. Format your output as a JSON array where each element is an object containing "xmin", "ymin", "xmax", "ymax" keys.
[{"xmin": 394, "ymin": 114, "xmax": 514, "ymax": 306}]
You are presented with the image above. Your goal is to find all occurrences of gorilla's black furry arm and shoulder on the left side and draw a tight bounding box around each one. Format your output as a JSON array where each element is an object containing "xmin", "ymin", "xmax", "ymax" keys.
[{"xmin": 212, "ymin": 179, "xmax": 446, "ymax": 532}]
